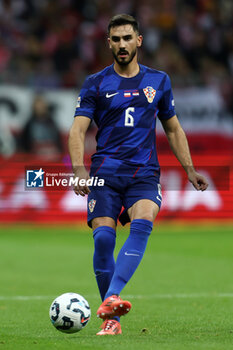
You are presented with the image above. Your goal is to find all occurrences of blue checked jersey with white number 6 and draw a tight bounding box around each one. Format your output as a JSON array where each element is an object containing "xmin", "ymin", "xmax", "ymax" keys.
[{"xmin": 75, "ymin": 65, "xmax": 175, "ymax": 177}]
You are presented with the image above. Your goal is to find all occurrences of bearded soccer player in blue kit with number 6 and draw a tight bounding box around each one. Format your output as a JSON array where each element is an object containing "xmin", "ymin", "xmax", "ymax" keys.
[{"xmin": 69, "ymin": 14, "xmax": 208, "ymax": 335}]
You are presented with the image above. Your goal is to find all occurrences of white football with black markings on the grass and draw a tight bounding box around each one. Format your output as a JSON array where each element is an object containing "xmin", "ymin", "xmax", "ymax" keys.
[{"xmin": 49, "ymin": 293, "xmax": 91, "ymax": 333}]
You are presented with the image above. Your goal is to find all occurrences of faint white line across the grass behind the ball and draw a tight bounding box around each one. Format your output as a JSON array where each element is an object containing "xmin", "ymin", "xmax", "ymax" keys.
[{"xmin": 0, "ymin": 293, "xmax": 233, "ymax": 301}]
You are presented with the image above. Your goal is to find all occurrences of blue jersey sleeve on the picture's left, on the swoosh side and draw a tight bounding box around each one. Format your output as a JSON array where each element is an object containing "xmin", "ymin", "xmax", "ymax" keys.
[{"xmin": 74, "ymin": 77, "xmax": 97, "ymax": 120}]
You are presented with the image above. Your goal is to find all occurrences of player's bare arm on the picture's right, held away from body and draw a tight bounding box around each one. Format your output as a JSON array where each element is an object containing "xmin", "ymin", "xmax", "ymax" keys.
[{"xmin": 161, "ymin": 115, "xmax": 208, "ymax": 191}]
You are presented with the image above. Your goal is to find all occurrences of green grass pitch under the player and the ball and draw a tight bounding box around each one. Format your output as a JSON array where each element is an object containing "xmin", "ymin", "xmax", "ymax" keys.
[{"xmin": 0, "ymin": 223, "xmax": 233, "ymax": 350}]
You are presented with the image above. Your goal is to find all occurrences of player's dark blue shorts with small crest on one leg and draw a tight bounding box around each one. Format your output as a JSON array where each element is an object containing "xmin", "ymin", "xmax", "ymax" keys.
[{"xmin": 87, "ymin": 176, "xmax": 162, "ymax": 227}]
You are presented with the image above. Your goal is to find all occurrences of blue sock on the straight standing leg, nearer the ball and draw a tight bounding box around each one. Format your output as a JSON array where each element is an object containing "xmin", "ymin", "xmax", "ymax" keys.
[{"xmin": 93, "ymin": 226, "xmax": 116, "ymax": 300}]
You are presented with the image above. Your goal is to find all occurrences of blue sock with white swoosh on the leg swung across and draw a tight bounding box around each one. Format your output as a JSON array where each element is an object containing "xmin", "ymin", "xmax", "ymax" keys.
[{"xmin": 105, "ymin": 219, "xmax": 153, "ymax": 299}]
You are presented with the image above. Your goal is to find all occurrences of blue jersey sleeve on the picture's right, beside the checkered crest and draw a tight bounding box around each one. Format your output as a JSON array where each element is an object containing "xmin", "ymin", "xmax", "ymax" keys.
[{"xmin": 158, "ymin": 74, "xmax": 176, "ymax": 120}]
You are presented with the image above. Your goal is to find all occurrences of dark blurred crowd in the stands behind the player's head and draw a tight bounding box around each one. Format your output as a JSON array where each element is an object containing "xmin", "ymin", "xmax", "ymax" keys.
[{"xmin": 0, "ymin": 0, "xmax": 233, "ymax": 106}]
